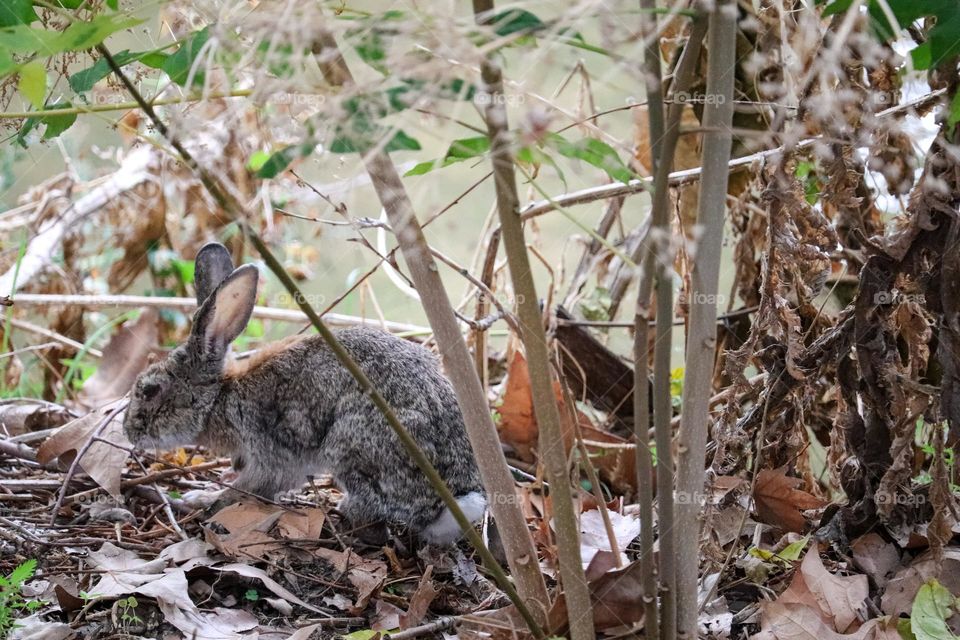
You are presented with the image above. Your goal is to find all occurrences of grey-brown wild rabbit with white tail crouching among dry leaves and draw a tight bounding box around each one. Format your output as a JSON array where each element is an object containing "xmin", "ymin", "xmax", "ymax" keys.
[{"xmin": 124, "ymin": 243, "xmax": 486, "ymax": 544}]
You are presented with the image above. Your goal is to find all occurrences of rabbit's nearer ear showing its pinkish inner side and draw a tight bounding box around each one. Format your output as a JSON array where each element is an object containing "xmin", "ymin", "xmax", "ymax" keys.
[{"xmin": 190, "ymin": 264, "xmax": 260, "ymax": 362}]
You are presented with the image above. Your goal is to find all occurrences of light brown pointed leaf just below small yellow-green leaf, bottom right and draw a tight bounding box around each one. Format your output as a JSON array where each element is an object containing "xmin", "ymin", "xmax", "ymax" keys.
[{"xmin": 764, "ymin": 546, "xmax": 869, "ymax": 633}]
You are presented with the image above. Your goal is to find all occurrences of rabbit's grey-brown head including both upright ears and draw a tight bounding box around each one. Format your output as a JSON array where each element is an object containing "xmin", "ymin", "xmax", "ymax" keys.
[{"xmin": 123, "ymin": 243, "xmax": 258, "ymax": 448}]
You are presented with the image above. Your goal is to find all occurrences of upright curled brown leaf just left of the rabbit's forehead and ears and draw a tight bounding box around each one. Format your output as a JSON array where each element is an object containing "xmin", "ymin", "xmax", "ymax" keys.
[{"xmin": 79, "ymin": 307, "xmax": 160, "ymax": 407}]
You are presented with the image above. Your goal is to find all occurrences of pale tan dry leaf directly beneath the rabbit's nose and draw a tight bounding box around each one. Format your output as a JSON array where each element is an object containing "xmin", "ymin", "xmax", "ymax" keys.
[{"xmin": 37, "ymin": 404, "xmax": 133, "ymax": 497}]
